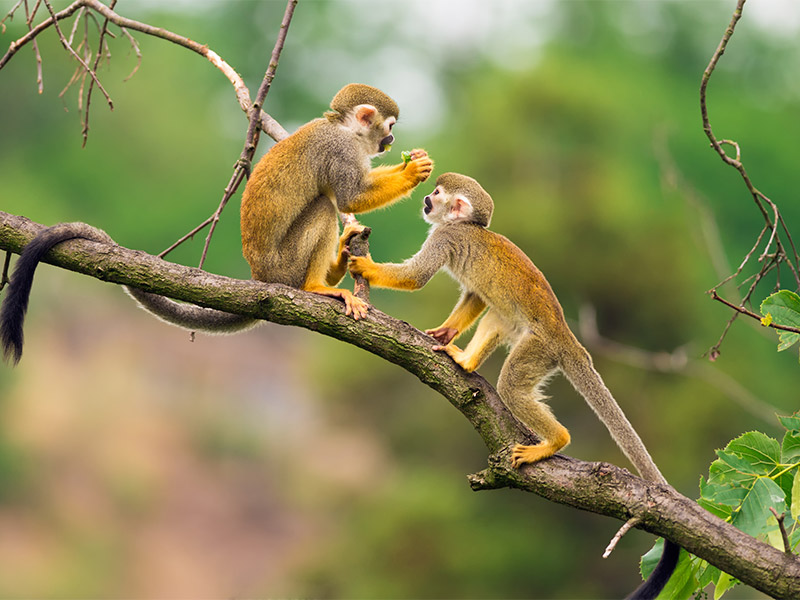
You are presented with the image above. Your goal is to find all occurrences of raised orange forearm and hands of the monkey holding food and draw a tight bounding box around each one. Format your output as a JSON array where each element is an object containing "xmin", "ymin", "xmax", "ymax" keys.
[{"xmin": 336, "ymin": 150, "xmax": 433, "ymax": 213}]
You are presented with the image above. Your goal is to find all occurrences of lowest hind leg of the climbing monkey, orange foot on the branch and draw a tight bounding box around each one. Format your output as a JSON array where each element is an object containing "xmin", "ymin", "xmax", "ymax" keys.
[{"xmin": 497, "ymin": 336, "xmax": 570, "ymax": 468}]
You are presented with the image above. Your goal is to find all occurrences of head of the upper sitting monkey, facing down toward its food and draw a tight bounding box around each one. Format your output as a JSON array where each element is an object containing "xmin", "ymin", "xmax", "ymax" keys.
[{"xmin": 325, "ymin": 83, "xmax": 400, "ymax": 156}]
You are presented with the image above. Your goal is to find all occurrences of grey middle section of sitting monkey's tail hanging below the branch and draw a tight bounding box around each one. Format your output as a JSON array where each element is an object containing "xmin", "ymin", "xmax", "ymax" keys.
[{"xmin": 124, "ymin": 286, "xmax": 260, "ymax": 334}]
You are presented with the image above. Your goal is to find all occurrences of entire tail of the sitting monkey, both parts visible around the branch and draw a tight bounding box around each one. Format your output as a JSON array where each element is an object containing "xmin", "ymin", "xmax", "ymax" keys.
[{"xmin": 0, "ymin": 223, "xmax": 259, "ymax": 364}]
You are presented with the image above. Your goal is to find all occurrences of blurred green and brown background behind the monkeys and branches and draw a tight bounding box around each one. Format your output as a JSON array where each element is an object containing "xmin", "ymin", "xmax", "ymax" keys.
[{"xmin": 0, "ymin": 0, "xmax": 800, "ymax": 598}]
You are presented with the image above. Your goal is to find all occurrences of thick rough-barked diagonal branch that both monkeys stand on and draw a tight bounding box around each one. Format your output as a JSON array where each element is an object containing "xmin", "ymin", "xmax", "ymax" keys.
[{"xmin": 0, "ymin": 212, "xmax": 800, "ymax": 598}]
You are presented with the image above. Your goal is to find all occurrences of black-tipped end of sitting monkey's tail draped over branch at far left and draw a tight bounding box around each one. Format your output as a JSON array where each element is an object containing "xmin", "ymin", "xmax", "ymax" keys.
[{"xmin": 0, "ymin": 223, "xmax": 114, "ymax": 364}]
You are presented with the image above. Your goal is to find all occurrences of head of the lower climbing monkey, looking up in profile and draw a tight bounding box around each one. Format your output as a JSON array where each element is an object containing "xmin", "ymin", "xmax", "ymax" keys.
[{"xmin": 422, "ymin": 173, "xmax": 494, "ymax": 227}]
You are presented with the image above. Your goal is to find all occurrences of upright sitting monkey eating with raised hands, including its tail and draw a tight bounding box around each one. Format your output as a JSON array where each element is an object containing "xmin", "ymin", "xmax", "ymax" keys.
[{"xmin": 0, "ymin": 83, "xmax": 433, "ymax": 362}]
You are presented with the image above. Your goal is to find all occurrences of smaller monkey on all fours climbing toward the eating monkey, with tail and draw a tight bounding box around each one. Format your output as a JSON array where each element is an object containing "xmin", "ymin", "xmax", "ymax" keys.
[{"xmin": 349, "ymin": 173, "xmax": 679, "ymax": 599}]
